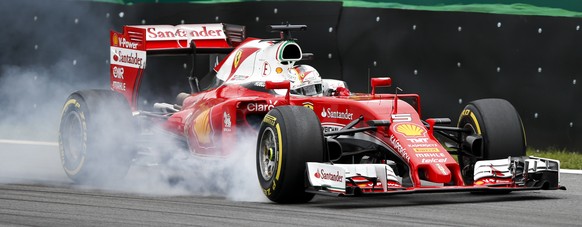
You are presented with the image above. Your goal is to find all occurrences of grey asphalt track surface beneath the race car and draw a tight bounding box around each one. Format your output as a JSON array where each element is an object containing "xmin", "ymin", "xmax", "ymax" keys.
[{"xmin": 0, "ymin": 141, "xmax": 582, "ymax": 226}]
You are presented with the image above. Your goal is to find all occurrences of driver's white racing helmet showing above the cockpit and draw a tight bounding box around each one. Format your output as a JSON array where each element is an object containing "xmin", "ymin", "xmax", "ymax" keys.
[{"xmin": 289, "ymin": 65, "xmax": 323, "ymax": 96}]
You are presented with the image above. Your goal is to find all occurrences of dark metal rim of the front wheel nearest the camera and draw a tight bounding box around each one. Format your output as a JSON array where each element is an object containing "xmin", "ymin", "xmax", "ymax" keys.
[{"xmin": 259, "ymin": 127, "xmax": 279, "ymax": 181}]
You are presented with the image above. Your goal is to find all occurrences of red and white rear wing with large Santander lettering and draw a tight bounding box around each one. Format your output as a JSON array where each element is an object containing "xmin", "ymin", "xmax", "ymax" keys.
[{"xmin": 109, "ymin": 23, "xmax": 245, "ymax": 110}]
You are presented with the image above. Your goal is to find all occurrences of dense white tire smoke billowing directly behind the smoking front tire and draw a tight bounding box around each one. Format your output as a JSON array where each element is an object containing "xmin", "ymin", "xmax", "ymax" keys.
[{"xmin": 108, "ymin": 130, "xmax": 267, "ymax": 202}]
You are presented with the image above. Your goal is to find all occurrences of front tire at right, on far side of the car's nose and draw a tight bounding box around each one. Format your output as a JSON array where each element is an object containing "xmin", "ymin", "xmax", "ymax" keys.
[{"xmin": 457, "ymin": 99, "xmax": 526, "ymax": 185}]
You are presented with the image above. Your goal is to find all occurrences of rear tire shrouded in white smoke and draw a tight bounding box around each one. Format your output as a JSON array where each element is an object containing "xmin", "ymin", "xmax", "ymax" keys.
[{"xmin": 59, "ymin": 90, "xmax": 136, "ymax": 184}]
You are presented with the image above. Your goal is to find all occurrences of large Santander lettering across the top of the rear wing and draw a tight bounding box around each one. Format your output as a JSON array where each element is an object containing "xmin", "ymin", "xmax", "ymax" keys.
[{"xmin": 147, "ymin": 26, "xmax": 225, "ymax": 40}]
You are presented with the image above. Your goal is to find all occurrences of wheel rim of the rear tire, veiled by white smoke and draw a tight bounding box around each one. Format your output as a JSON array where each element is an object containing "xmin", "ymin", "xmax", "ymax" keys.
[{"xmin": 61, "ymin": 111, "xmax": 85, "ymax": 170}]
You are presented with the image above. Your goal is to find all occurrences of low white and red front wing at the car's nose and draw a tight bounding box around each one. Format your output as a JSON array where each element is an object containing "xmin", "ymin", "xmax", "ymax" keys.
[{"xmin": 306, "ymin": 157, "xmax": 566, "ymax": 196}]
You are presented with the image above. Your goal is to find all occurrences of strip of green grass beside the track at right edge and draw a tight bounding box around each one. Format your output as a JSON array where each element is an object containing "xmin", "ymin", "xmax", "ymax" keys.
[{"xmin": 527, "ymin": 148, "xmax": 582, "ymax": 169}]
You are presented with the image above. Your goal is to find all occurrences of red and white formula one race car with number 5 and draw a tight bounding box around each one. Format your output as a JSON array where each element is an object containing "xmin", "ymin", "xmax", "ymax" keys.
[{"xmin": 59, "ymin": 24, "xmax": 563, "ymax": 203}]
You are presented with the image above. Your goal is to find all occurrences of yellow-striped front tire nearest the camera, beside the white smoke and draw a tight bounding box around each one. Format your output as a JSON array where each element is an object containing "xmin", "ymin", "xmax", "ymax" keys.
[{"xmin": 257, "ymin": 106, "xmax": 324, "ymax": 203}]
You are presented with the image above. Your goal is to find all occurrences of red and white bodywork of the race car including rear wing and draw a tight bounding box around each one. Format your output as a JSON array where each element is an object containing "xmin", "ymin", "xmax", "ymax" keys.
[{"xmin": 110, "ymin": 24, "xmax": 560, "ymax": 192}]
